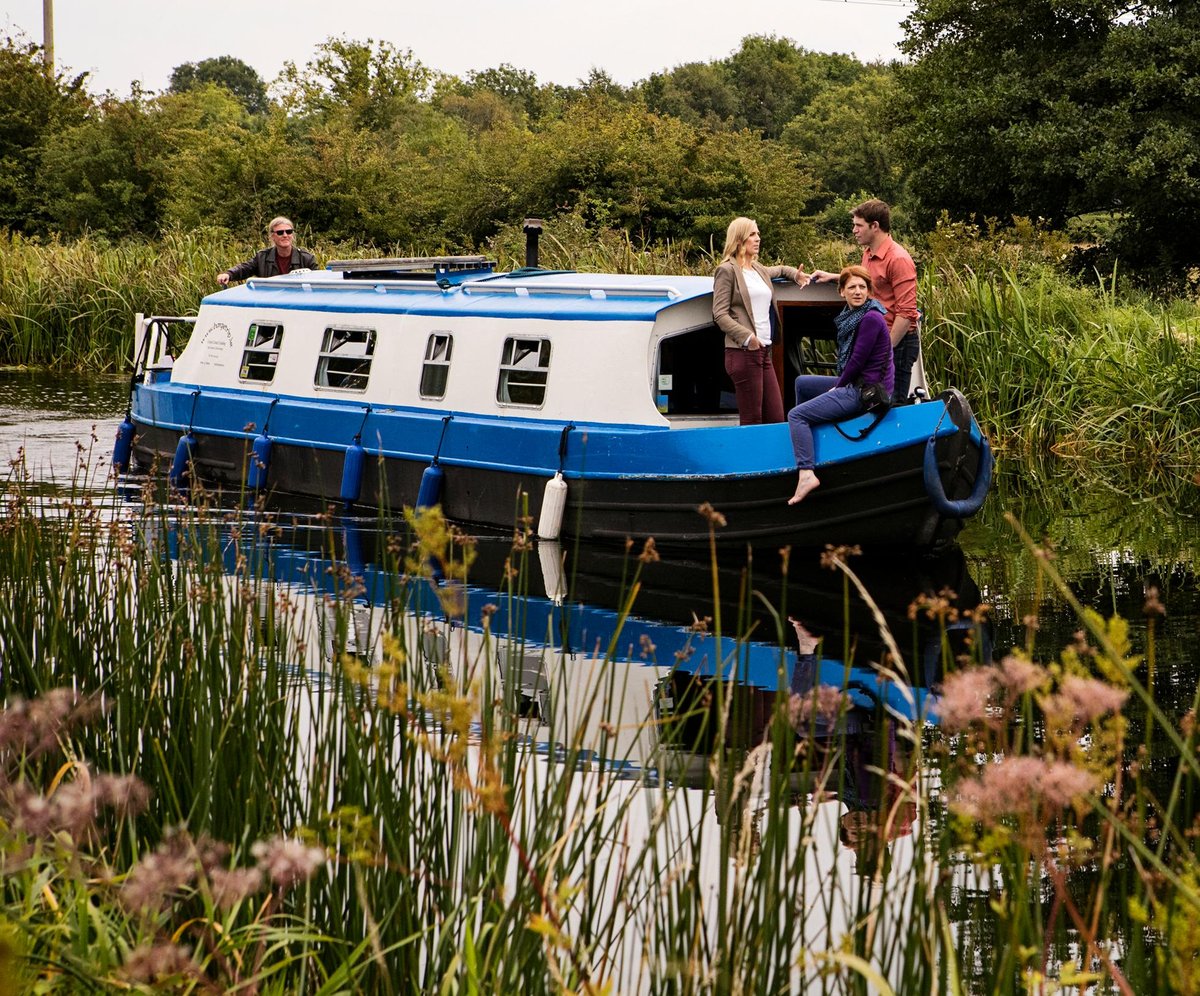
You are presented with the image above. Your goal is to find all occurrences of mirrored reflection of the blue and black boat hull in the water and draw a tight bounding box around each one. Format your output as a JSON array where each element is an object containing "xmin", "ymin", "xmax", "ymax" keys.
[{"xmin": 168, "ymin": 506, "xmax": 990, "ymax": 796}]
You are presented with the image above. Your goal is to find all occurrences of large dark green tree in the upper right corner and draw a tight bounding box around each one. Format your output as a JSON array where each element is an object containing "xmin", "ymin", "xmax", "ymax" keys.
[{"xmin": 899, "ymin": 0, "xmax": 1200, "ymax": 269}]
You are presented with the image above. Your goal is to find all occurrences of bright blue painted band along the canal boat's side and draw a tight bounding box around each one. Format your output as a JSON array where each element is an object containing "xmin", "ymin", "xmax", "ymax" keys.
[{"xmin": 133, "ymin": 384, "xmax": 973, "ymax": 480}]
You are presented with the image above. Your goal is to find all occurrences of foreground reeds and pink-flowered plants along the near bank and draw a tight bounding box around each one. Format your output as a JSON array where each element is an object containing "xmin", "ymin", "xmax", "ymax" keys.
[{"xmin": 0, "ymin": 468, "xmax": 1200, "ymax": 994}]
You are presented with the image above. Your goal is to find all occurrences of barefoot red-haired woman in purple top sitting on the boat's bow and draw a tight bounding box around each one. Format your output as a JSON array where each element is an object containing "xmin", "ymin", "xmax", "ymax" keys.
[{"xmin": 787, "ymin": 266, "xmax": 895, "ymax": 505}]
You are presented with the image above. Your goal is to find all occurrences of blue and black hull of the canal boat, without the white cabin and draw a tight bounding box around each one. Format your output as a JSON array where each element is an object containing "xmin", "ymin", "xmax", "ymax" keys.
[{"xmin": 126, "ymin": 385, "xmax": 990, "ymax": 547}]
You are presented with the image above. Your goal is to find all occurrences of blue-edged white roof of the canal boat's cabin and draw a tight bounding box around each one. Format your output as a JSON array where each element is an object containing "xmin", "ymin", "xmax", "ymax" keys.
[{"xmin": 204, "ymin": 270, "xmax": 713, "ymax": 322}]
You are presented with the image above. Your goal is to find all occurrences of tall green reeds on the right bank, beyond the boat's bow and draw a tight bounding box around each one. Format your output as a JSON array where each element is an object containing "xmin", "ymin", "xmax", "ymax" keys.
[{"xmin": 922, "ymin": 270, "xmax": 1200, "ymax": 480}]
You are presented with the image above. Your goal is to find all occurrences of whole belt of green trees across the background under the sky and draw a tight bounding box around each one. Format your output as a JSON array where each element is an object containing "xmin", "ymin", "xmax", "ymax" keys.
[{"xmin": 0, "ymin": 23, "xmax": 1200, "ymax": 275}]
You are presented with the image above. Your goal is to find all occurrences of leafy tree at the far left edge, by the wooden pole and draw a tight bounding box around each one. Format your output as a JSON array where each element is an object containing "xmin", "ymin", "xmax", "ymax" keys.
[{"xmin": 0, "ymin": 37, "xmax": 91, "ymax": 232}]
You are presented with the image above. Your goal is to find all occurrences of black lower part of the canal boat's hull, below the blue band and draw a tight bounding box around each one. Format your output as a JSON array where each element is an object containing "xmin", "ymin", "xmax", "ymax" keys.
[{"xmin": 133, "ymin": 425, "xmax": 979, "ymax": 547}]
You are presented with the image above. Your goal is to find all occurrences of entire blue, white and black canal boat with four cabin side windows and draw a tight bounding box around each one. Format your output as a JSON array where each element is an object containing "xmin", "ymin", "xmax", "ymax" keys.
[{"xmin": 114, "ymin": 232, "xmax": 991, "ymax": 546}]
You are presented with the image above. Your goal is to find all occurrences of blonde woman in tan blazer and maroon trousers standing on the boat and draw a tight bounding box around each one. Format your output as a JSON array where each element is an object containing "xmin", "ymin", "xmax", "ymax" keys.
[{"xmin": 713, "ymin": 218, "xmax": 809, "ymax": 425}]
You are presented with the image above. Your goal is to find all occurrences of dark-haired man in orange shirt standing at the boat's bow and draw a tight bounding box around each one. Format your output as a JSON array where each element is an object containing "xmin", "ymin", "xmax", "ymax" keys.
[{"xmin": 812, "ymin": 199, "xmax": 920, "ymax": 404}]
